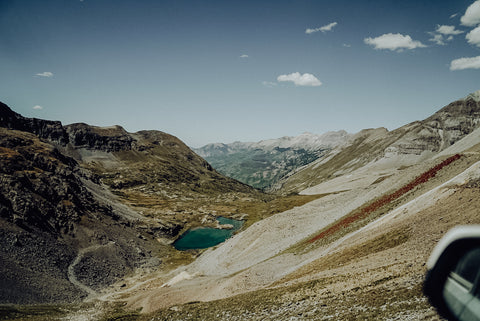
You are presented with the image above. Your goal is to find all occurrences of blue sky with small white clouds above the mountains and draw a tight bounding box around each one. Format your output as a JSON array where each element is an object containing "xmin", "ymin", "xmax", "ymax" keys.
[{"xmin": 0, "ymin": 0, "xmax": 480, "ymax": 147}]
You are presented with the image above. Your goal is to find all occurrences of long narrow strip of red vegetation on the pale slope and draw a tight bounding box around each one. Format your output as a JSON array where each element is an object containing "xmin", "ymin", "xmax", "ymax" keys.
[{"xmin": 308, "ymin": 154, "xmax": 461, "ymax": 243}]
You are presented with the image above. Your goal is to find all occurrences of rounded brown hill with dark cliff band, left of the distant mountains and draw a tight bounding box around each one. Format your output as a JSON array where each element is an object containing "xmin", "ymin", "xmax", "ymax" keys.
[{"xmin": 63, "ymin": 124, "xmax": 253, "ymax": 199}]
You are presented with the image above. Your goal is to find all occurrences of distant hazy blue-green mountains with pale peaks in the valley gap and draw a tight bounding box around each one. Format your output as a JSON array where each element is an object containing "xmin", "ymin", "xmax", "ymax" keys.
[{"xmin": 193, "ymin": 131, "xmax": 350, "ymax": 190}]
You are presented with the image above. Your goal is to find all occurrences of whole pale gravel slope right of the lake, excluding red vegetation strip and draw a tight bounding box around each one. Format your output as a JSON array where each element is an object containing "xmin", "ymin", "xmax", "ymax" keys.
[{"xmin": 65, "ymin": 154, "xmax": 480, "ymax": 320}]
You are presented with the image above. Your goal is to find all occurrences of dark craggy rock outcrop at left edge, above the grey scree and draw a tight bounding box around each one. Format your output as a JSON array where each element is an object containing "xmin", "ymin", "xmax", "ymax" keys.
[{"xmin": 0, "ymin": 128, "xmax": 94, "ymax": 234}]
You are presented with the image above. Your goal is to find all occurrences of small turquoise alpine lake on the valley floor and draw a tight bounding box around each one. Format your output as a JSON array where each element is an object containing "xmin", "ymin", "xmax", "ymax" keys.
[{"xmin": 173, "ymin": 216, "xmax": 243, "ymax": 251}]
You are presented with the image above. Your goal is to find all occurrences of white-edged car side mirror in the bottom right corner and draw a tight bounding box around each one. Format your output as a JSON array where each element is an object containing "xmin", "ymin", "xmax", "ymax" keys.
[{"xmin": 424, "ymin": 225, "xmax": 480, "ymax": 321}]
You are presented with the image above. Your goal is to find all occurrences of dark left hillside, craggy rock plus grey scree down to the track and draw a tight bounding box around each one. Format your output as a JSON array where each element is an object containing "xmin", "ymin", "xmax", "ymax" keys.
[{"xmin": 0, "ymin": 128, "xmax": 163, "ymax": 303}]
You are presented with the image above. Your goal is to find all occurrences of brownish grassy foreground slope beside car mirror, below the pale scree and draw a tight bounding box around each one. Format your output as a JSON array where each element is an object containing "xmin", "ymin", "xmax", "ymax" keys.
[{"xmin": 142, "ymin": 178, "xmax": 480, "ymax": 320}]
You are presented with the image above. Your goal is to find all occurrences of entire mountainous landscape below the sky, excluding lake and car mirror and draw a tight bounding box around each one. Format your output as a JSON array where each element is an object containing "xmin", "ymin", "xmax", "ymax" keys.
[{"xmin": 0, "ymin": 91, "xmax": 480, "ymax": 320}]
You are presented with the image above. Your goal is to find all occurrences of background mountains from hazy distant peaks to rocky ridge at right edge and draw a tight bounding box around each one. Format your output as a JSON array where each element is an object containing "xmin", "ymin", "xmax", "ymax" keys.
[{"xmin": 197, "ymin": 91, "xmax": 480, "ymax": 193}]
